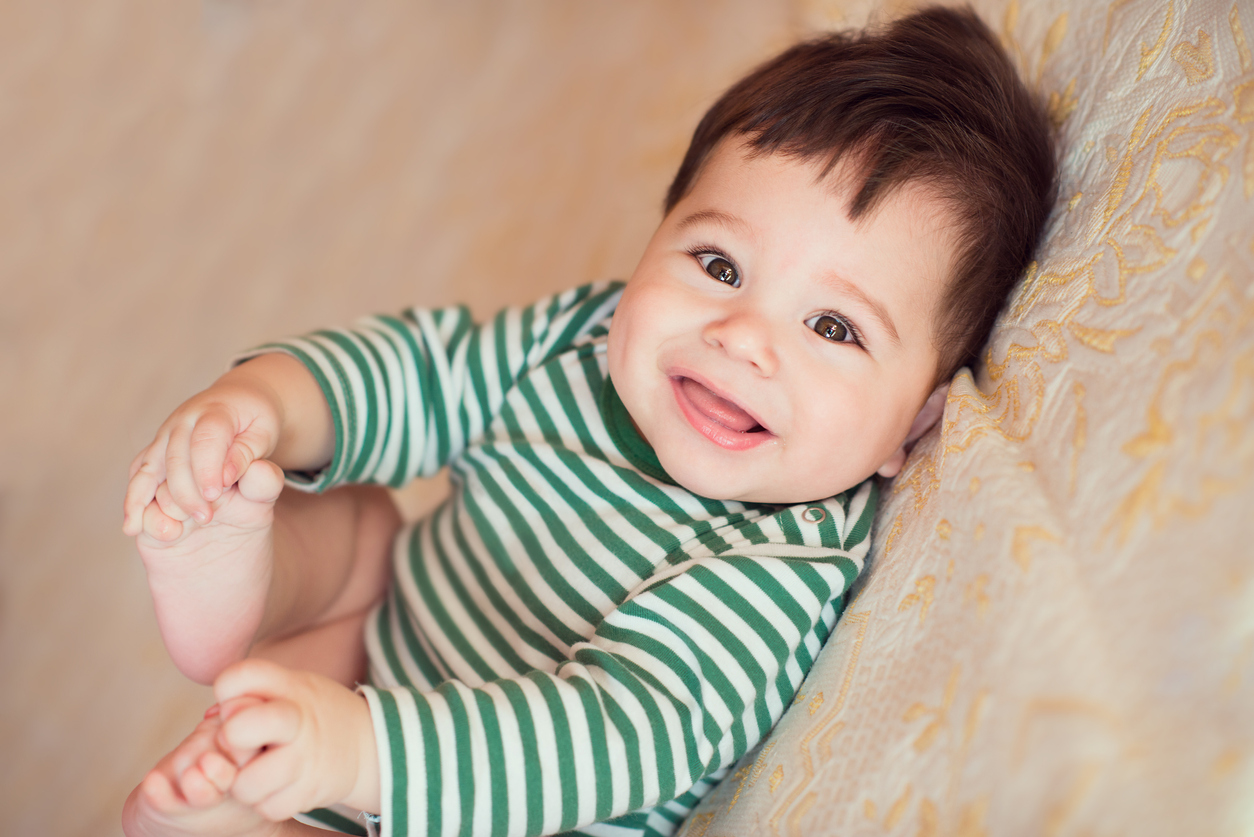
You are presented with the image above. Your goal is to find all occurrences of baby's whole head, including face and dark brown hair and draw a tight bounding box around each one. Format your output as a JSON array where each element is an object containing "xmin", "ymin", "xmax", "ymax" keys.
[{"xmin": 608, "ymin": 9, "xmax": 1055, "ymax": 503}]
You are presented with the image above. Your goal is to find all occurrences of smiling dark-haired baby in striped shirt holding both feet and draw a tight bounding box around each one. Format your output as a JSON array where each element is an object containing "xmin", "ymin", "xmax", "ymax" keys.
[{"xmin": 124, "ymin": 9, "xmax": 1053, "ymax": 837}]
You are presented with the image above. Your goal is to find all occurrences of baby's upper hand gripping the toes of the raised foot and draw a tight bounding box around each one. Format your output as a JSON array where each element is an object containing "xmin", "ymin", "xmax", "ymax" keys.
[{"xmin": 122, "ymin": 355, "xmax": 283, "ymax": 540}]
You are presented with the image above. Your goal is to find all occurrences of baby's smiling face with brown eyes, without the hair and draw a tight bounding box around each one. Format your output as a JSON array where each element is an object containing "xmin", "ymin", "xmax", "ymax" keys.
[{"xmin": 608, "ymin": 142, "xmax": 956, "ymax": 503}]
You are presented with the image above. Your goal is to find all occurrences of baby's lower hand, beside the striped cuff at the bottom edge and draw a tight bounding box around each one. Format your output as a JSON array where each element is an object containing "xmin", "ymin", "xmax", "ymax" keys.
[{"xmin": 213, "ymin": 659, "xmax": 379, "ymax": 822}]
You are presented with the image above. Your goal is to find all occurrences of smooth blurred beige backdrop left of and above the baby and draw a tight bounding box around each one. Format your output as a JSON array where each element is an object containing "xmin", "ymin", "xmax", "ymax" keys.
[{"xmin": 0, "ymin": 0, "xmax": 832, "ymax": 836}]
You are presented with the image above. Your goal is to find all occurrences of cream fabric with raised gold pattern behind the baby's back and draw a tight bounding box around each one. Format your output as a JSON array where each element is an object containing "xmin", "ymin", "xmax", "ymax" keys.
[{"xmin": 683, "ymin": 0, "xmax": 1254, "ymax": 837}]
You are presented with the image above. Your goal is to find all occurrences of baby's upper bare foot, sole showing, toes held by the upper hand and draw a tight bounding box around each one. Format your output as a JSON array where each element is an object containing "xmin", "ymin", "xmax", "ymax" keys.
[{"xmin": 135, "ymin": 459, "xmax": 283, "ymax": 684}]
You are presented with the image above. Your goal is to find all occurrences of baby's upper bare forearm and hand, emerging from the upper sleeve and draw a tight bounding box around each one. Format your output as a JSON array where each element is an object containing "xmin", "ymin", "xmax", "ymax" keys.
[{"xmin": 122, "ymin": 354, "xmax": 335, "ymax": 537}]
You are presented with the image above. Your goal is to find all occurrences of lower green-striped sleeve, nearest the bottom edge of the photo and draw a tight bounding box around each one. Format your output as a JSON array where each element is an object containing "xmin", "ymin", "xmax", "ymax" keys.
[{"xmin": 365, "ymin": 484, "xmax": 874, "ymax": 836}]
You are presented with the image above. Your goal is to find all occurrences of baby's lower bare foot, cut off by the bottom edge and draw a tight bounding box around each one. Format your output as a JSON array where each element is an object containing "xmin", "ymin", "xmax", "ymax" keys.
[{"xmin": 122, "ymin": 699, "xmax": 274, "ymax": 837}]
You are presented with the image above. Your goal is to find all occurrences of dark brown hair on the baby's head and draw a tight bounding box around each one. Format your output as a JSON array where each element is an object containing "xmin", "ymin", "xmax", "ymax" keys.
[{"xmin": 666, "ymin": 8, "xmax": 1055, "ymax": 383}]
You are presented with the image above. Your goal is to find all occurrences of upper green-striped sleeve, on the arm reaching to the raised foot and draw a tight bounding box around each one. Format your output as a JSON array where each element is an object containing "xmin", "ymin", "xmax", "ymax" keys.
[{"xmin": 241, "ymin": 282, "xmax": 622, "ymax": 491}]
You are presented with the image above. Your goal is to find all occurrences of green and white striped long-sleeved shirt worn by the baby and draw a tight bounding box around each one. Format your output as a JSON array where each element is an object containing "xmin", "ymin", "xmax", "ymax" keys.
[{"xmin": 263, "ymin": 284, "xmax": 875, "ymax": 836}]
